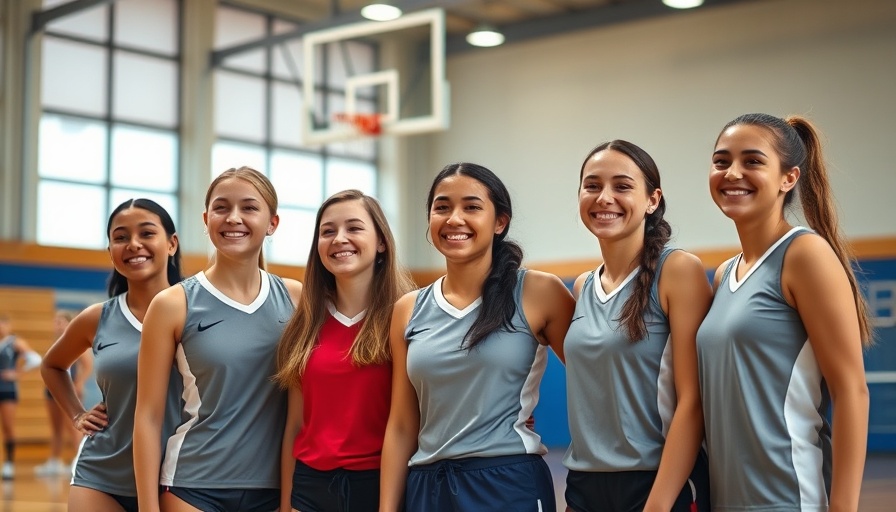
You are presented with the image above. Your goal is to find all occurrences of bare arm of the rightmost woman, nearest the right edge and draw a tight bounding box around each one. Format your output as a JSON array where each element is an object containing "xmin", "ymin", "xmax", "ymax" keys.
[{"xmin": 781, "ymin": 235, "xmax": 869, "ymax": 512}]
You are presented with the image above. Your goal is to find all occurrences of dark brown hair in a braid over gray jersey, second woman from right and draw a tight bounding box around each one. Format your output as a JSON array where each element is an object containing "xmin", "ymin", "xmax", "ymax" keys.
[{"xmin": 579, "ymin": 139, "xmax": 672, "ymax": 342}]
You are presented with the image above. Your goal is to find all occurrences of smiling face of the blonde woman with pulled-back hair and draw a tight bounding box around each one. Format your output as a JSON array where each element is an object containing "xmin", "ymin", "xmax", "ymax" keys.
[{"xmin": 202, "ymin": 178, "xmax": 279, "ymax": 258}]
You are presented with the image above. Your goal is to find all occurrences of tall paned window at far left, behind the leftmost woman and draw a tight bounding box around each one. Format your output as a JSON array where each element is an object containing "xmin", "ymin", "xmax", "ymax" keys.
[{"xmin": 37, "ymin": 0, "xmax": 181, "ymax": 249}]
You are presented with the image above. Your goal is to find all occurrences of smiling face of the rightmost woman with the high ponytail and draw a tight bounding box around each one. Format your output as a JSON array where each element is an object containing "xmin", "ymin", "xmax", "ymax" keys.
[{"xmin": 709, "ymin": 124, "xmax": 800, "ymax": 221}]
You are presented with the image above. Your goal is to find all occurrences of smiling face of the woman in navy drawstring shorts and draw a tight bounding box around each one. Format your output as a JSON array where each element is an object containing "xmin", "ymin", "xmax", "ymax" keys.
[{"xmin": 429, "ymin": 174, "xmax": 507, "ymax": 260}]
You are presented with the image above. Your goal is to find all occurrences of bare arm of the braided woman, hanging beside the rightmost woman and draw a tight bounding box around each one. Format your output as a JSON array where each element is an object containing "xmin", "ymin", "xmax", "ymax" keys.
[{"xmin": 644, "ymin": 251, "xmax": 712, "ymax": 512}]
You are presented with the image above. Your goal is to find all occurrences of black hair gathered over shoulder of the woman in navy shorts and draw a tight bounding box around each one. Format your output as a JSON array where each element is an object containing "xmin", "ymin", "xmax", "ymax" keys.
[{"xmin": 426, "ymin": 163, "xmax": 523, "ymax": 349}]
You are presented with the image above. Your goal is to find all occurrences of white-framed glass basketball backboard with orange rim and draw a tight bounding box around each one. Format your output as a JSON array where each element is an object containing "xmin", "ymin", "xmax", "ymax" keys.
[{"xmin": 301, "ymin": 9, "xmax": 450, "ymax": 145}]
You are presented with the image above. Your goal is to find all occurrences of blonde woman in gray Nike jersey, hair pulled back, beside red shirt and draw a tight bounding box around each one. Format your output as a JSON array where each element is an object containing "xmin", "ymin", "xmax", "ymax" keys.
[{"xmin": 134, "ymin": 167, "xmax": 302, "ymax": 512}]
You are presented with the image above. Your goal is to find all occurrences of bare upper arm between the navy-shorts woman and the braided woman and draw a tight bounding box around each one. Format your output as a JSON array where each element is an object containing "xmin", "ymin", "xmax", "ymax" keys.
[{"xmin": 523, "ymin": 270, "xmax": 576, "ymax": 364}]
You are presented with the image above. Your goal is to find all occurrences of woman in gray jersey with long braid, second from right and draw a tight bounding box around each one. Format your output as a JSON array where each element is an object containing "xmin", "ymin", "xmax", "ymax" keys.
[{"xmin": 563, "ymin": 140, "xmax": 712, "ymax": 512}]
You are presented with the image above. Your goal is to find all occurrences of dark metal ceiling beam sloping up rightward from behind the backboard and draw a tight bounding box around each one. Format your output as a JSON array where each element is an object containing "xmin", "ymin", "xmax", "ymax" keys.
[{"xmin": 445, "ymin": 0, "xmax": 753, "ymax": 55}]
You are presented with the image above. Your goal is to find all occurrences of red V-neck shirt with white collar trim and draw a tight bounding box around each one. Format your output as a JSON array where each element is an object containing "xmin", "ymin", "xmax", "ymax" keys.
[{"xmin": 292, "ymin": 308, "xmax": 392, "ymax": 471}]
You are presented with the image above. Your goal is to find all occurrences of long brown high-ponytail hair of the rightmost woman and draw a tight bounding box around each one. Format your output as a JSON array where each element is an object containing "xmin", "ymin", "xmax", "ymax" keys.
[{"xmin": 716, "ymin": 114, "xmax": 873, "ymax": 347}]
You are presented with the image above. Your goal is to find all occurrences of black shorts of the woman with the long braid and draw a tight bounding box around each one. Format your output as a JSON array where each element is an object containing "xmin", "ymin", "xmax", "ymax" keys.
[{"xmin": 566, "ymin": 450, "xmax": 710, "ymax": 512}]
